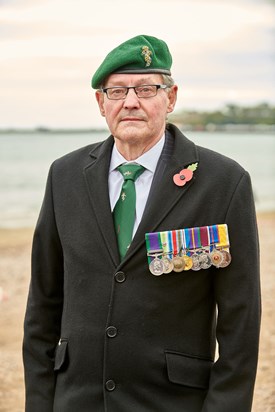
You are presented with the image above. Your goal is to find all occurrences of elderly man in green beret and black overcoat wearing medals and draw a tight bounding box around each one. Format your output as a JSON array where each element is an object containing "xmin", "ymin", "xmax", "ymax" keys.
[{"xmin": 23, "ymin": 35, "xmax": 260, "ymax": 412}]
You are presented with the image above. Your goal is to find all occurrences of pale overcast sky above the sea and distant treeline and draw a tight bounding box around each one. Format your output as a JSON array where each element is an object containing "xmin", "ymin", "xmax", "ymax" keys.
[{"xmin": 0, "ymin": 0, "xmax": 275, "ymax": 128}]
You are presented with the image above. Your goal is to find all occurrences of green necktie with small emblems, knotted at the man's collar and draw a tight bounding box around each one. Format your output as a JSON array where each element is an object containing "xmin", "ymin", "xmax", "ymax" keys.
[{"xmin": 113, "ymin": 164, "xmax": 145, "ymax": 259}]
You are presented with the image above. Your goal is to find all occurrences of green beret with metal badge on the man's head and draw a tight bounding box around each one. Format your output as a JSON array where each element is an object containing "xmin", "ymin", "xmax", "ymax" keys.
[{"xmin": 92, "ymin": 35, "xmax": 172, "ymax": 89}]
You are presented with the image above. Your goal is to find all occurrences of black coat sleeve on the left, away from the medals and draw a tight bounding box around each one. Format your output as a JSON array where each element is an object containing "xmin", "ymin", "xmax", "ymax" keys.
[{"xmin": 23, "ymin": 163, "xmax": 63, "ymax": 412}]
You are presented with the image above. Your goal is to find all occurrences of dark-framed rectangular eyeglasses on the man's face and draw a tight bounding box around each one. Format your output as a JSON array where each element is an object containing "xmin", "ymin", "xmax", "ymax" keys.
[{"xmin": 101, "ymin": 84, "xmax": 168, "ymax": 100}]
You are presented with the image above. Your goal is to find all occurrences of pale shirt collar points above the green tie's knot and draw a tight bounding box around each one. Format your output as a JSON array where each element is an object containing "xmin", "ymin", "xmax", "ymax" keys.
[{"xmin": 109, "ymin": 135, "xmax": 165, "ymax": 173}]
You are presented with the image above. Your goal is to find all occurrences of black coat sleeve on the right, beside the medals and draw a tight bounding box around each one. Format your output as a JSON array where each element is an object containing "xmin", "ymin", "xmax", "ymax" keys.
[{"xmin": 202, "ymin": 173, "xmax": 261, "ymax": 412}]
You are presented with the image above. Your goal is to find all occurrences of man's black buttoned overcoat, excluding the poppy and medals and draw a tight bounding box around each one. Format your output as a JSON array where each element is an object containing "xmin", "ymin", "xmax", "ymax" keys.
[{"xmin": 23, "ymin": 125, "xmax": 260, "ymax": 412}]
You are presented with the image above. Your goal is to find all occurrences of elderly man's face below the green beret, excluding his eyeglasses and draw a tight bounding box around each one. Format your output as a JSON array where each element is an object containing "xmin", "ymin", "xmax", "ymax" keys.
[{"xmin": 96, "ymin": 73, "xmax": 177, "ymax": 151}]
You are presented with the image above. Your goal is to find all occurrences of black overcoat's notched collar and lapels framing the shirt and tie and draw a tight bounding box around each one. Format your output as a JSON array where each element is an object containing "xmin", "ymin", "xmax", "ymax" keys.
[{"xmin": 84, "ymin": 124, "xmax": 199, "ymax": 266}]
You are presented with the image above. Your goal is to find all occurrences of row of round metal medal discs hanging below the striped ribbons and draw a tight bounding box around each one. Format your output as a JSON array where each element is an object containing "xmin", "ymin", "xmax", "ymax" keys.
[{"xmin": 148, "ymin": 248, "xmax": 231, "ymax": 276}]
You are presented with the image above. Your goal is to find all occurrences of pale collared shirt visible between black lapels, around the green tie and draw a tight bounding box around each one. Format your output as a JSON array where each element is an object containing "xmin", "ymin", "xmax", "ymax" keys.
[{"xmin": 108, "ymin": 135, "xmax": 165, "ymax": 236}]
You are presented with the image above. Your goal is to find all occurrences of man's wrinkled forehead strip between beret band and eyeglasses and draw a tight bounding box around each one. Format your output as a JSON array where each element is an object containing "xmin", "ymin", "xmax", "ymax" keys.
[{"xmin": 104, "ymin": 73, "xmax": 162, "ymax": 87}]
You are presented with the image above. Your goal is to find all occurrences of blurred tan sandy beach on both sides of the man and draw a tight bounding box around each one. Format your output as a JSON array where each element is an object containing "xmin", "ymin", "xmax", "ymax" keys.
[{"xmin": 0, "ymin": 213, "xmax": 275, "ymax": 412}]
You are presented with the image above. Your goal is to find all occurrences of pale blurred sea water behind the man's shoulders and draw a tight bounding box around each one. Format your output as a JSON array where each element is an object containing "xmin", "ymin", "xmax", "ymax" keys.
[{"xmin": 0, "ymin": 131, "xmax": 275, "ymax": 227}]
